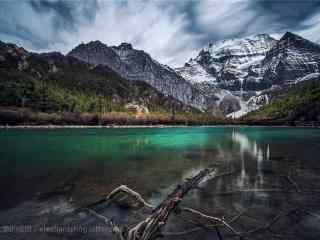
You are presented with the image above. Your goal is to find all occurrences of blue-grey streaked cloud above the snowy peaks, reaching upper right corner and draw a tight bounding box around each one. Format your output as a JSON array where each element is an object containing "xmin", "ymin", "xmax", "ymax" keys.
[{"xmin": 197, "ymin": 0, "xmax": 320, "ymax": 43}]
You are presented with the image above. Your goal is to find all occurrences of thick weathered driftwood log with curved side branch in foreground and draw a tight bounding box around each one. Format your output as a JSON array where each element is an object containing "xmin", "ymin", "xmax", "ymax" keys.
[{"xmin": 85, "ymin": 169, "xmax": 214, "ymax": 240}]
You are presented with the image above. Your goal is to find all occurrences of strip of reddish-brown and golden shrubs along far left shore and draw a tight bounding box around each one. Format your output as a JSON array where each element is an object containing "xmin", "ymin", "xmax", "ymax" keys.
[{"xmin": 0, "ymin": 107, "xmax": 231, "ymax": 125}]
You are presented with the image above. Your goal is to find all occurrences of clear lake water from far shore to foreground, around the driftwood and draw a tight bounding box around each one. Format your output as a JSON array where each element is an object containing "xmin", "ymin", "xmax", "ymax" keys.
[{"xmin": 0, "ymin": 127, "xmax": 320, "ymax": 239}]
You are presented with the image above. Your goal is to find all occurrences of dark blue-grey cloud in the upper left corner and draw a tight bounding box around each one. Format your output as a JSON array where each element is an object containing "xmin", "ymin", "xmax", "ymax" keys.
[{"xmin": 0, "ymin": 0, "xmax": 98, "ymax": 50}]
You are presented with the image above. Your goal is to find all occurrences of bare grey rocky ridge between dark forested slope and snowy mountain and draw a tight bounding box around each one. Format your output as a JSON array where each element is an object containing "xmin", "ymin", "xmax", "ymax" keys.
[{"xmin": 68, "ymin": 41, "xmax": 210, "ymax": 111}]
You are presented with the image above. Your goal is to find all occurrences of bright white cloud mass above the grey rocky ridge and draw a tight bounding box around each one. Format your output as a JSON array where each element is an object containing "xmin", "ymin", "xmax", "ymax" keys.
[{"xmin": 38, "ymin": 0, "xmax": 200, "ymax": 66}]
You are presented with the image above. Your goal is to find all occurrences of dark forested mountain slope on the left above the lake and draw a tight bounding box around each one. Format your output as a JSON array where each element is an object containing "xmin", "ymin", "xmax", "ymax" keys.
[{"xmin": 0, "ymin": 41, "xmax": 194, "ymax": 111}]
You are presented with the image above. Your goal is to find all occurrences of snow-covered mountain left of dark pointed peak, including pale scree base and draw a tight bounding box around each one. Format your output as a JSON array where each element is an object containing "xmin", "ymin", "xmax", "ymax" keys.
[{"xmin": 175, "ymin": 34, "xmax": 277, "ymax": 117}]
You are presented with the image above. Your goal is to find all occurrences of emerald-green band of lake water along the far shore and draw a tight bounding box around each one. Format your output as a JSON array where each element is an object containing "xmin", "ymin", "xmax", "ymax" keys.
[{"xmin": 0, "ymin": 128, "xmax": 320, "ymax": 175}]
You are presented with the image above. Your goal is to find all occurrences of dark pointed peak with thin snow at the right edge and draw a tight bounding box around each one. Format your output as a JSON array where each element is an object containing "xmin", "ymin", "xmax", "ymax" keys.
[{"xmin": 261, "ymin": 32, "xmax": 320, "ymax": 85}]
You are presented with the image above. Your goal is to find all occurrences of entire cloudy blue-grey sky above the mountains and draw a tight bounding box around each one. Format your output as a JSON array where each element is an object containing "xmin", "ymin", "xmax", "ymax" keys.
[{"xmin": 0, "ymin": 0, "xmax": 320, "ymax": 66}]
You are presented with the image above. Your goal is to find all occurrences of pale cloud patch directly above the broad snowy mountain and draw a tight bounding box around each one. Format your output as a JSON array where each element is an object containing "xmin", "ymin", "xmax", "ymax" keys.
[{"xmin": 196, "ymin": 0, "xmax": 279, "ymax": 38}]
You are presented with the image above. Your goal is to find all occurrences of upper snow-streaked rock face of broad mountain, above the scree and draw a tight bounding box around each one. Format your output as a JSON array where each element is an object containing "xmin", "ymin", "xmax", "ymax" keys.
[{"xmin": 176, "ymin": 34, "xmax": 276, "ymax": 91}]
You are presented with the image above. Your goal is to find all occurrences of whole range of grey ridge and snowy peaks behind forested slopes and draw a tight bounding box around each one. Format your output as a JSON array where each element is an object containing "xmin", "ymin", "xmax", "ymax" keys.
[{"xmin": 69, "ymin": 33, "xmax": 320, "ymax": 116}]
